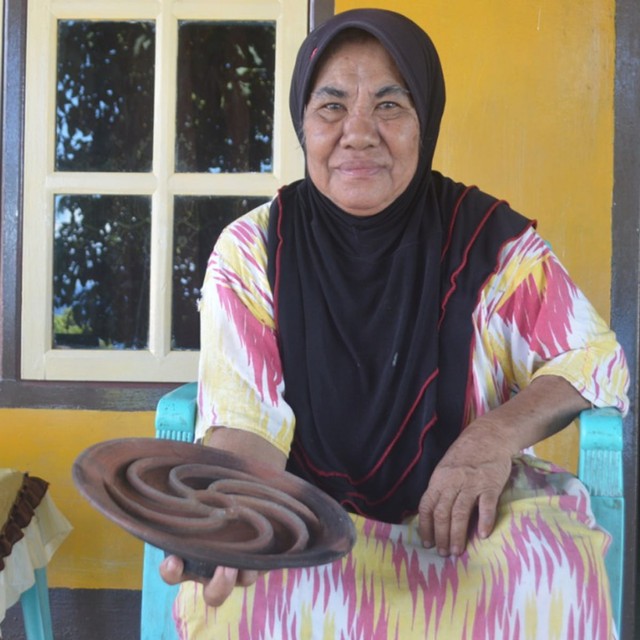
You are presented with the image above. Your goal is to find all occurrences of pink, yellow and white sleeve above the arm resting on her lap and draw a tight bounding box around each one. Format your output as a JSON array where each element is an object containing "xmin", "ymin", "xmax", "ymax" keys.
[{"xmin": 472, "ymin": 229, "xmax": 629, "ymax": 414}]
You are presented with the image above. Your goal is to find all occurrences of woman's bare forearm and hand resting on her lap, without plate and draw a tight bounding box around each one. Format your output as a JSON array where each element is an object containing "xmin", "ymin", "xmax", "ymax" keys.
[{"xmin": 418, "ymin": 375, "xmax": 589, "ymax": 556}]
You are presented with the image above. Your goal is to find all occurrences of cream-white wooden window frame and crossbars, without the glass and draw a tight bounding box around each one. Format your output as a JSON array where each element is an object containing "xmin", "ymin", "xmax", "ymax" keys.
[{"xmin": 21, "ymin": 0, "xmax": 307, "ymax": 382}]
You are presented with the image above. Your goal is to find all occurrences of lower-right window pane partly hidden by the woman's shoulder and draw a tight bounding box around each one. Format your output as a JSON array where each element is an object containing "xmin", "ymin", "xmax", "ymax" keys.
[{"xmin": 172, "ymin": 196, "xmax": 267, "ymax": 349}]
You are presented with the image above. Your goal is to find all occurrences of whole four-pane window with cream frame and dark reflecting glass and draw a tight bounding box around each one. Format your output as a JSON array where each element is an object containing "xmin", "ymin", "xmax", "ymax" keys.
[{"xmin": 20, "ymin": 0, "xmax": 307, "ymax": 382}]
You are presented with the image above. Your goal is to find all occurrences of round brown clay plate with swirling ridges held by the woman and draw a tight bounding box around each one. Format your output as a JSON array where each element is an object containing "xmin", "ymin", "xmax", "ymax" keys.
[{"xmin": 73, "ymin": 438, "xmax": 355, "ymax": 575}]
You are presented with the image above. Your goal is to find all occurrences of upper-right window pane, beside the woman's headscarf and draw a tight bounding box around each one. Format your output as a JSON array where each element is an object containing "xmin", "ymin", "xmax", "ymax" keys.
[{"xmin": 176, "ymin": 22, "xmax": 276, "ymax": 173}]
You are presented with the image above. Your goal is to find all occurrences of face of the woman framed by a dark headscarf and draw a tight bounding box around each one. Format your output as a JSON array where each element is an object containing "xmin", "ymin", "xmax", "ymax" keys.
[{"xmin": 303, "ymin": 40, "xmax": 420, "ymax": 216}]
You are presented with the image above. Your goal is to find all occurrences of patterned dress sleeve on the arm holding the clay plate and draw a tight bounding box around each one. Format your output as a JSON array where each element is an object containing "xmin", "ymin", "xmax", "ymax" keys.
[{"xmin": 196, "ymin": 207, "xmax": 295, "ymax": 456}]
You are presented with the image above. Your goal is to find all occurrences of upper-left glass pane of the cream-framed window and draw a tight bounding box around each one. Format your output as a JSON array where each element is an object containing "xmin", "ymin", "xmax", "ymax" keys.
[{"xmin": 55, "ymin": 21, "xmax": 155, "ymax": 172}]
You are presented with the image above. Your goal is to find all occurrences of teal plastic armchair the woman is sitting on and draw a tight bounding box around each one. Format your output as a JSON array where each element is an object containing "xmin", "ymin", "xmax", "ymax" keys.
[{"xmin": 141, "ymin": 383, "xmax": 624, "ymax": 640}]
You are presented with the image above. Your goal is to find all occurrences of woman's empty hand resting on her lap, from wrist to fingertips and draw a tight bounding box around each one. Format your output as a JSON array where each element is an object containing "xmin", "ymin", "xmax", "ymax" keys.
[{"xmin": 419, "ymin": 418, "xmax": 515, "ymax": 556}]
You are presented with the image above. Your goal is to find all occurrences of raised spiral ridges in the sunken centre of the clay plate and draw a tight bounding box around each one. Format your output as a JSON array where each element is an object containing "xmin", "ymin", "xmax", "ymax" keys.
[{"xmin": 107, "ymin": 456, "xmax": 321, "ymax": 554}]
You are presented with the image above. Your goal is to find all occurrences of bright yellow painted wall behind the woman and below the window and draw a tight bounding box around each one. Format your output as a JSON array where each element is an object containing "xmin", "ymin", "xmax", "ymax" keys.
[{"xmin": 0, "ymin": 0, "xmax": 614, "ymax": 588}]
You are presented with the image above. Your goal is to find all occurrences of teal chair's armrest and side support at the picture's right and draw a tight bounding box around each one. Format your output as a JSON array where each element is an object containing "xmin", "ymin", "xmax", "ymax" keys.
[{"xmin": 578, "ymin": 408, "xmax": 625, "ymax": 633}]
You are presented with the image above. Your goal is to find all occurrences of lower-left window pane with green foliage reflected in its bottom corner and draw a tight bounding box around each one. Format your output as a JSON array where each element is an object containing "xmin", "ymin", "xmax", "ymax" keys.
[{"xmin": 53, "ymin": 195, "xmax": 151, "ymax": 349}]
